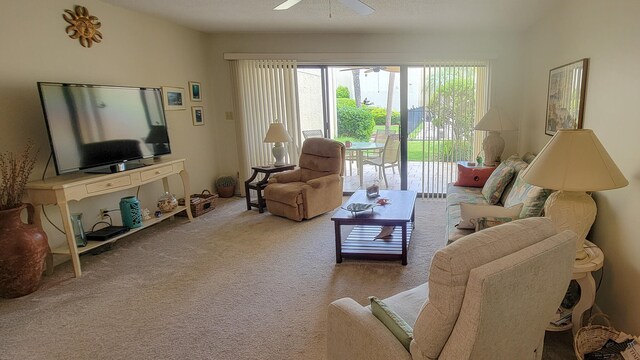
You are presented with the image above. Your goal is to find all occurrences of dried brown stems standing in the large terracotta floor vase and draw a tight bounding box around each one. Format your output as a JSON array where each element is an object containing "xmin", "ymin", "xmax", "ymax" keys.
[{"xmin": 0, "ymin": 142, "xmax": 49, "ymax": 298}]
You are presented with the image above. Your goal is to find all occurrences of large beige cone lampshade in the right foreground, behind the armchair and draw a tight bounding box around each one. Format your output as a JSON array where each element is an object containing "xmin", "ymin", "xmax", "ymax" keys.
[{"xmin": 522, "ymin": 129, "xmax": 629, "ymax": 191}]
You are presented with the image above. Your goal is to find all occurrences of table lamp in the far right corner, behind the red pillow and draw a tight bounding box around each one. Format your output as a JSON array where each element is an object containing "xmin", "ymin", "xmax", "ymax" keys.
[{"xmin": 475, "ymin": 108, "xmax": 517, "ymax": 166}]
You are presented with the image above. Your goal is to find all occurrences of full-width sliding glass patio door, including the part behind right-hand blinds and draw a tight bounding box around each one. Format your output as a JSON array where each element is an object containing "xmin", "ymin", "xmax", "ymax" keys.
[{"xmin": 298, "ymin": 62, "xmax": 488, "ymax": 197}]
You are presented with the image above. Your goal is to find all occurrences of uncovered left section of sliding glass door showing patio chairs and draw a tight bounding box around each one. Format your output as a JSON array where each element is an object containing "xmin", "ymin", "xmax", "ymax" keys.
[{"xmin": 298, "ymin": 66, "xmax": 401, "ymax": 193}]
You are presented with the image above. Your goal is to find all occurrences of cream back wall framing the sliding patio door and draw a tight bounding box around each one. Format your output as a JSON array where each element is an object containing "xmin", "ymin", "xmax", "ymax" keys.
[{"xmin": 209, "ymin": 34, "xmax": 523, "ymax": 177}]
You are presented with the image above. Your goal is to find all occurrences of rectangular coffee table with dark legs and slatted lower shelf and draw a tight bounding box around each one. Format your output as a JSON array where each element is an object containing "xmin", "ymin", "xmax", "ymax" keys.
[{"xmin": 331, "ymin": 190, "xmax": 417, "ymax": 265}]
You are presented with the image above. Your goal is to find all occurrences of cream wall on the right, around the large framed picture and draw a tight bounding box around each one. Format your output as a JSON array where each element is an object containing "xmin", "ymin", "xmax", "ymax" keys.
[{"xmin": 520, "ymin": 0, "xmax": 640, "ymax": 335}]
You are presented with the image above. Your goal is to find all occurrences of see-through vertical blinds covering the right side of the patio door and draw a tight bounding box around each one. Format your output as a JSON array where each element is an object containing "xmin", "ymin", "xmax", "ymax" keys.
[{"xmin": 414, "ymin": 62, "xmax": 490, "ymax": 198}]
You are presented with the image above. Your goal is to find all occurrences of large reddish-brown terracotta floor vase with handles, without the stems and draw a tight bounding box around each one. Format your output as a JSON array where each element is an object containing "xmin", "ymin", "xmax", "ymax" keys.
[{"xmin": 0, "ymin": 204, "xmax": 49, "ymax": 298}]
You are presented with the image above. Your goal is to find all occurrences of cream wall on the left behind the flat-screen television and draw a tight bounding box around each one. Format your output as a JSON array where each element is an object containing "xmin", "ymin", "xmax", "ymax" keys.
[{"xmin": 0, "ymin": 0, "xmax": 217, "ymax": 252}]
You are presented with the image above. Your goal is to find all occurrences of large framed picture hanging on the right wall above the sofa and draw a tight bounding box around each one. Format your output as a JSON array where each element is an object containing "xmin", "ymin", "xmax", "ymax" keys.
[{"xmin": 544, "ymin": 59, "xmax": 589, "ymax": 136}]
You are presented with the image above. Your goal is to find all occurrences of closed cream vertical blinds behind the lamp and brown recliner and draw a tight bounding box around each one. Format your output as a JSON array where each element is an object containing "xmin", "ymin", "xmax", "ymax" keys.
[{"xmin": 230, "ymin": 60, "xmax": 302, "ymax": 195}]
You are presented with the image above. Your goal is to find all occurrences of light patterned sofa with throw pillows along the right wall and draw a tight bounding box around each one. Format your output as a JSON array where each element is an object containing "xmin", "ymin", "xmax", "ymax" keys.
[{"xmin": 446, "ymin": 153, "xmax": 552, "ymax": 244}]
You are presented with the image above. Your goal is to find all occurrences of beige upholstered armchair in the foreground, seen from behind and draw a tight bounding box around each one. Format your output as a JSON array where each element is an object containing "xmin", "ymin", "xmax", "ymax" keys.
[{"xmin": 327, "ymin": 218, "xmax": 576, "ymax": 360}]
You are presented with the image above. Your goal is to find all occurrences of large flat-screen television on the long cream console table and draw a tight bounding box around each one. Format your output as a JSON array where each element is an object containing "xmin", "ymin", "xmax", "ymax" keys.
[{"xmin": 38, "ymin": 82, "xmax": 171, "ymax": 175}]
